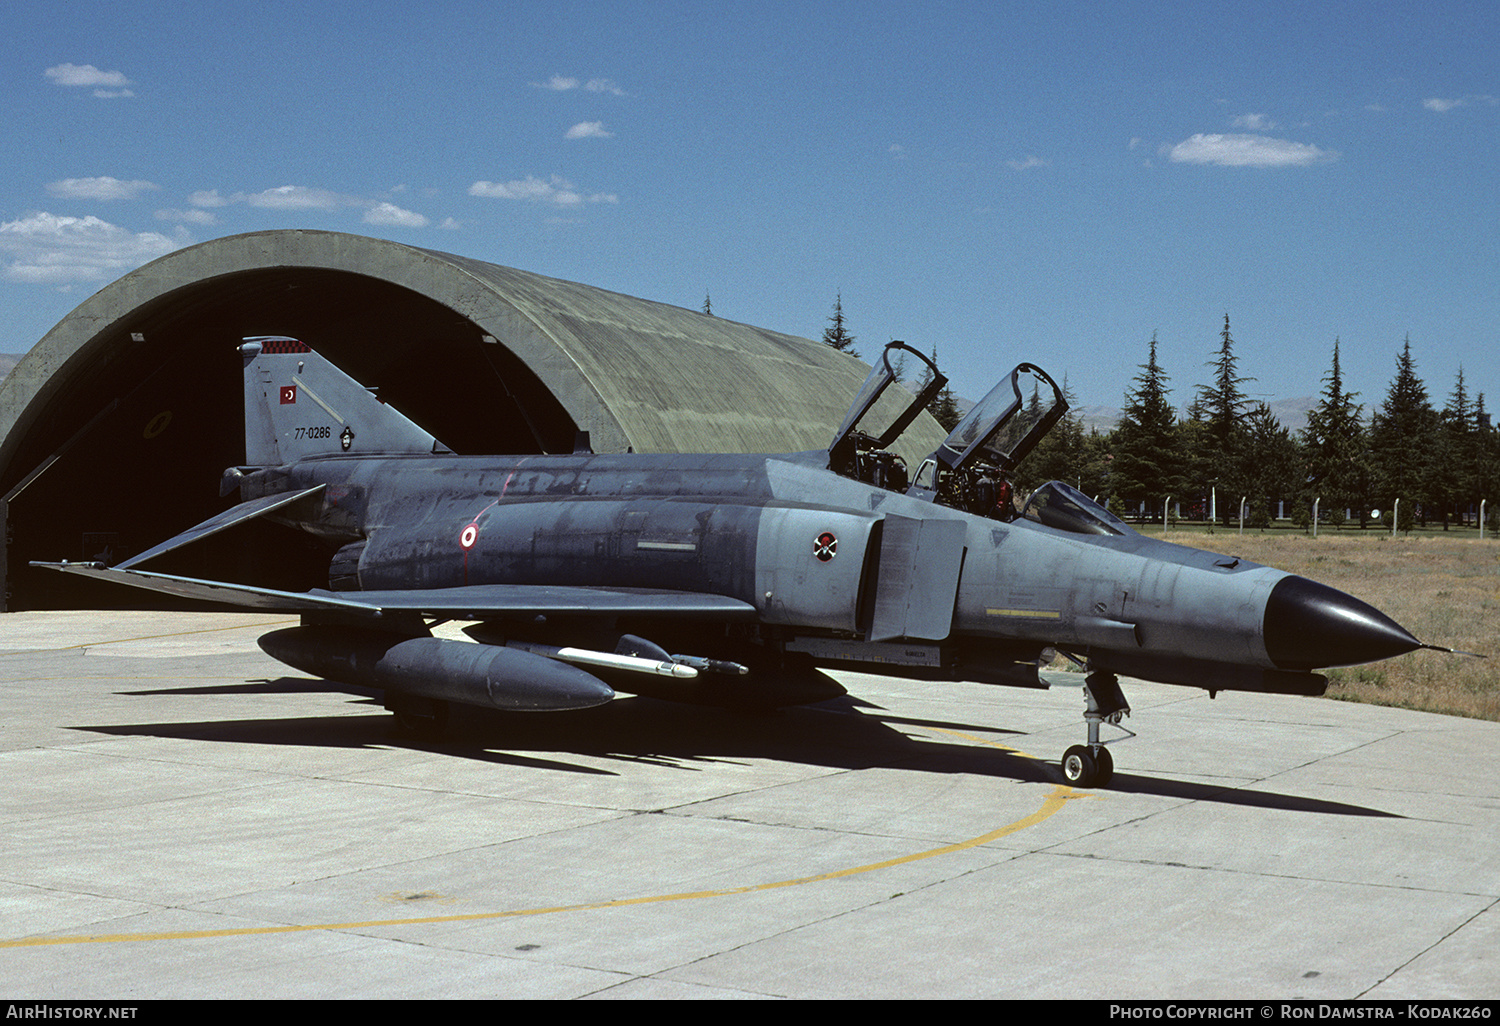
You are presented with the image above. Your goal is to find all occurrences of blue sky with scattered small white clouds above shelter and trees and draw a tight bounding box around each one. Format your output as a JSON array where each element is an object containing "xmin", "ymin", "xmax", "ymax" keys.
[{"xmin": 0, "ymin": 0, "xmax": 1500, "ymax": 411}]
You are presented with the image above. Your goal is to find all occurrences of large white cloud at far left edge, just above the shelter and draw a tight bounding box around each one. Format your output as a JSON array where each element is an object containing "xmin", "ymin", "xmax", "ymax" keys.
[{"xmin": 0, "ymin": 213, "xmax": 188, "ymax": 285}]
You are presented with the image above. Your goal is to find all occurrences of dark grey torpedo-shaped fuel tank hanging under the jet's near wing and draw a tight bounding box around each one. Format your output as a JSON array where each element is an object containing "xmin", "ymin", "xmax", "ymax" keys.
[{"xmin": 260, "ymin": 626, "xmax": 615, "ymax": 713}]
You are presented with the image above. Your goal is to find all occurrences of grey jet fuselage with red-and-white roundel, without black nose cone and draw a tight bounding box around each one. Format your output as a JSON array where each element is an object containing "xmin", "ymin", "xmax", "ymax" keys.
[{"xmin": 246, "ymin": 453, "xmax": 1364, "ymax": 693}]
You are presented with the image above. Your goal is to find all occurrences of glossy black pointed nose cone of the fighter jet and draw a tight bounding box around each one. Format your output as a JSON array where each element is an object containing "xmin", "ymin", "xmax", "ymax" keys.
[{"xmin": 1263, "ymin": 576, "xmax": 1422, "ymax": 671}]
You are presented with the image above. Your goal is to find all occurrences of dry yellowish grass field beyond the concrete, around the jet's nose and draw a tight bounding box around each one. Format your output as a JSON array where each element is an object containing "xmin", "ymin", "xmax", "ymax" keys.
[{"xmin": 1167, "ymin": 528, "xmax": 1500, "ymax": 720}]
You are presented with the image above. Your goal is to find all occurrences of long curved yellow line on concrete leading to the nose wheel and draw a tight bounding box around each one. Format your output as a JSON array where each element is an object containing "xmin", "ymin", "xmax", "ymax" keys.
[{"xmin": 0, "ymin": 728, "xmax": 1095, "ymax": 948}]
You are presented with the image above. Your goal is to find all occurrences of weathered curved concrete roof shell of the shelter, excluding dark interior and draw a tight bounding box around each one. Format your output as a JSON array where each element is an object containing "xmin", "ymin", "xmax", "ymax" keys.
[{"xmin": 0, "ymin": 231, "xmax": 888, "ymax": 464}]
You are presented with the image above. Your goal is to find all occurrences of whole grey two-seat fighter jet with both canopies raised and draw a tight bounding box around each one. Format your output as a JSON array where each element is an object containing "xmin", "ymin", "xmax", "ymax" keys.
[{"xmin": 33, "ymin": 336, "xmax": 1427, "ymax": 786}]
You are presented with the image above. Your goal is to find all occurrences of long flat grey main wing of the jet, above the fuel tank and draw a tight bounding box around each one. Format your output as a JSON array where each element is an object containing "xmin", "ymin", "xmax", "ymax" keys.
[{"xmin": 23, "ymin": 563, "xmax": 756, "ymax": 621}]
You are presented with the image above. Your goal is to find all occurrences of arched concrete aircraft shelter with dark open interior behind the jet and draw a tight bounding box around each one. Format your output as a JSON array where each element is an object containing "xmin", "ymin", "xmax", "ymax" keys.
[{"xmin": 0, "ymin": 231, "xmax": 941, "ymax": 609}]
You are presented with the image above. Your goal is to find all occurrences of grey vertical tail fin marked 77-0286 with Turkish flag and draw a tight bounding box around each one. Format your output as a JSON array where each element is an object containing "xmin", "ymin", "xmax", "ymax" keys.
[{"xmin": 240, "ymin": 335, "xmax": 438, "ymax": 467}]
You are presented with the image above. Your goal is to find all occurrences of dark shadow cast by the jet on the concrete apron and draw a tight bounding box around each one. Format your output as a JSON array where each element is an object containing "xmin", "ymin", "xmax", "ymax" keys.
[{"xmin": 87, "ymin": 677, "xmax": 1401, "ymax": 819}]
